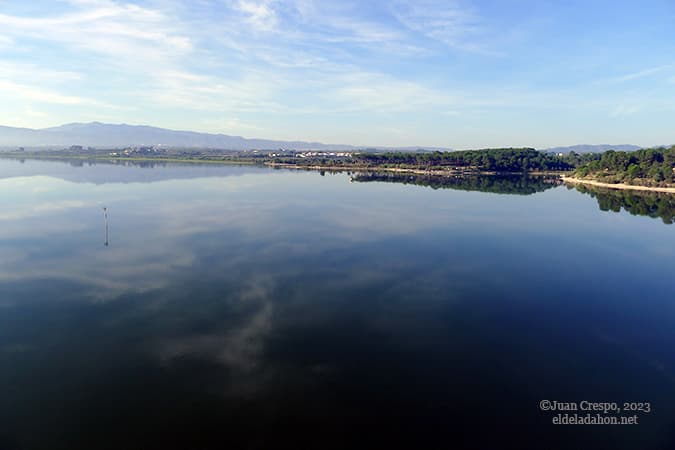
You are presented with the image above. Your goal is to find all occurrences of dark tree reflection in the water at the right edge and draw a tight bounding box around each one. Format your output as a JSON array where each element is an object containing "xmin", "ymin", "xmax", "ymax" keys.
[{"xmin": 570, "ymin": 185, "xmax": 675, "ymax": 224}]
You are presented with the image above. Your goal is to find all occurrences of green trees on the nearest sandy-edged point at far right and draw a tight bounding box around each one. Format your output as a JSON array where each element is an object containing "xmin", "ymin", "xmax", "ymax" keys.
[{"xmin": 574, "ymin": 146, "xmax": 675, "ymax": 186}]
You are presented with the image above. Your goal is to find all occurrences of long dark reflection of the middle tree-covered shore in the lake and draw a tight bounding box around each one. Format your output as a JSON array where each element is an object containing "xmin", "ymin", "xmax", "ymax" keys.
[{"xmin": 352, "ymin": 173, "xmax": 561, "ymax": 195}]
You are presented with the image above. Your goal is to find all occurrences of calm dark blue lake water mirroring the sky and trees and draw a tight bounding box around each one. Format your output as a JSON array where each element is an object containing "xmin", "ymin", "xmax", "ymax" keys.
[{"xmin": 0, "ymin": 160, "xmax": 675, "ymax": 450}]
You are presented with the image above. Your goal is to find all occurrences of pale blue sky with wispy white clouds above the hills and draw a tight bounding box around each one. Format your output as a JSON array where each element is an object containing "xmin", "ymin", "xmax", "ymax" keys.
[{"xmin": 0, "ymin": 0, "xmax": 675, "ymax": 149}]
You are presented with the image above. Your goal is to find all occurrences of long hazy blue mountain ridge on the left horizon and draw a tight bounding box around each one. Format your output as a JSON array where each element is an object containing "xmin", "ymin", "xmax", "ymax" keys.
[{"xmin": 0, "ymin": 122, "xmax": 448, "ymax": 150}]
